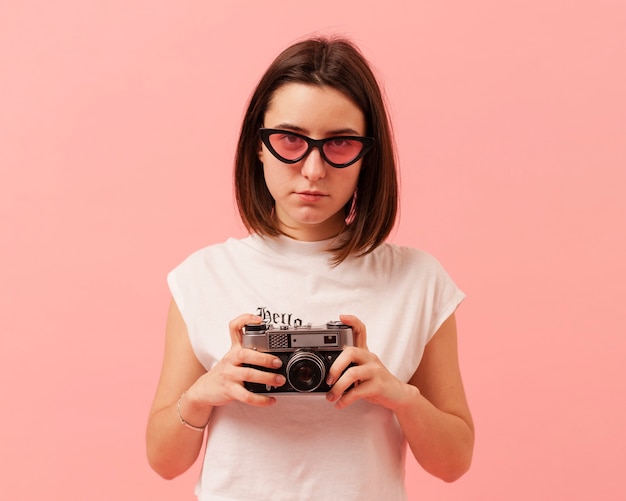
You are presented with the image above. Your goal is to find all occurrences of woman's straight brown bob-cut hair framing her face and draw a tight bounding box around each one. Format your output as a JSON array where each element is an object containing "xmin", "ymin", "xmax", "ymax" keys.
[{"xmin": 234, "ymin": 37, "xmax": 398, "ymax": 264}]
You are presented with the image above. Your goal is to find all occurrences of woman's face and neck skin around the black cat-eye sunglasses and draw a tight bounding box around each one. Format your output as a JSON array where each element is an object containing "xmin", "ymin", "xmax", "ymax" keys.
[{"xmin": 259, "ymin": 83, "xmax": 366, "ymax": 241}]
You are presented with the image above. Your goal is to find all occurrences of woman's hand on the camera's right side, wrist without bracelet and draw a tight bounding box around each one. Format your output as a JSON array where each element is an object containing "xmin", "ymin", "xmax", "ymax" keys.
[{"xmin": 326, "ymin": 315, "xmax": 416, "ymax": 409}]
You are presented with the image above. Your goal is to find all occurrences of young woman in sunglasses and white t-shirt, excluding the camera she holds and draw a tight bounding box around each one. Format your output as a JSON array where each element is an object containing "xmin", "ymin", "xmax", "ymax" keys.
[{"xmin": 147, "ymin": 39, "xmax": 474, "ymax": 501}]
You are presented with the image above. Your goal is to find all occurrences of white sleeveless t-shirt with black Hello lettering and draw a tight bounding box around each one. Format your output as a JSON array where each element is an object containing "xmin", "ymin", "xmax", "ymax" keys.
[{"xmin": 168, "ymin": 235, "xmax": 464, "ymax": 501}]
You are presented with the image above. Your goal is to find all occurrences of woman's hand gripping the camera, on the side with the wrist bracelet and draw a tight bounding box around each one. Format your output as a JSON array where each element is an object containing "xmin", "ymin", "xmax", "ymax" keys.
[{"xmin": 185, "ymin": 314, "xmax": 285, "ymax": 414}]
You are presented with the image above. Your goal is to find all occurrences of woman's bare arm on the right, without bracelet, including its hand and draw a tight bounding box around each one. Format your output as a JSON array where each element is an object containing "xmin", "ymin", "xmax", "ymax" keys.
[{"xmin": 327, "ymin": 315, "xmax": 474, "ymax": 482}]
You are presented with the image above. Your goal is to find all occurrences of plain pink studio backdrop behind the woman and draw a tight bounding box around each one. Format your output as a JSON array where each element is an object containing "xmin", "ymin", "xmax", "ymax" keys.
[{"xmin": 0, "ymin": 0, "xmax": 626, "ymax": 501}]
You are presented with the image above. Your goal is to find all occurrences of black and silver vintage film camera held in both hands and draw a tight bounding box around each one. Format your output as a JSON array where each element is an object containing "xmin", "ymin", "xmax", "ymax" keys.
[{"xmin": 242, "ymin": 321, "xmax": 354, "ymax": 393}]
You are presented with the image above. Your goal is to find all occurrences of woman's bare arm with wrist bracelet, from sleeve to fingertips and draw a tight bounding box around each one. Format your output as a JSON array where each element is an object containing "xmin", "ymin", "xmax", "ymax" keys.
[{"xmin": 146, "ymin": 300, "xmax": 284, "ymax": 478}]
